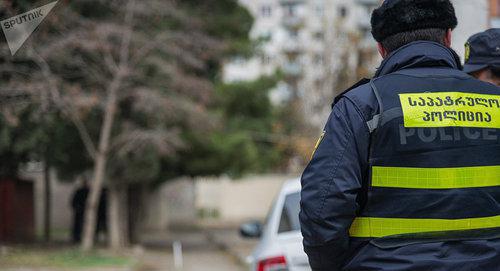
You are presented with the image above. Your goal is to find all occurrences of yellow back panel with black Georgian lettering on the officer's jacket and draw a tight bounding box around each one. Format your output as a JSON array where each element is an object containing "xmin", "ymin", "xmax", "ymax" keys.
[{"xmin": 399, "ymin": 92, "xmax": 500, "ymax": 129}]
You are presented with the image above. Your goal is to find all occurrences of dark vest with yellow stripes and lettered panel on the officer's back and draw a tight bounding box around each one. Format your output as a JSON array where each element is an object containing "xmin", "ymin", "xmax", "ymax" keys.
[{"xmin": 349, "ymin": 69, "xmax": 500, "ymax": 238}]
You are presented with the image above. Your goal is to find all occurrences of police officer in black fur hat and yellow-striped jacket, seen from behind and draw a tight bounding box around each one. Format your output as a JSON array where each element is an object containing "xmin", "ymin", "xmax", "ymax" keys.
[{"xmin": 300, "ymin": 0, "xmax": 500, "ymax": 271}]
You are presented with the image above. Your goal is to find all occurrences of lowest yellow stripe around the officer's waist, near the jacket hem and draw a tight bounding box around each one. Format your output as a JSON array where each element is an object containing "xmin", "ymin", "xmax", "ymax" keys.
[{"xmin": 349, "ymin": 216, "xmax": 500, "ymax": 237}]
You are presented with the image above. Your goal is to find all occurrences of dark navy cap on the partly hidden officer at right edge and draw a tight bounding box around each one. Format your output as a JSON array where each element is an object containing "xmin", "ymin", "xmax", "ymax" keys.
[{"xmin": 464, "ymin": 28, "xmax": 500, "ymax": 73}]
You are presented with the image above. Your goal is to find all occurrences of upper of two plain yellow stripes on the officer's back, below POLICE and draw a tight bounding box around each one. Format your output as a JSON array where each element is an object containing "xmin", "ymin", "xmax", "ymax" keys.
[{"xmin": 372, "ymin": 166, "xmax": 500, "ymax": 189}]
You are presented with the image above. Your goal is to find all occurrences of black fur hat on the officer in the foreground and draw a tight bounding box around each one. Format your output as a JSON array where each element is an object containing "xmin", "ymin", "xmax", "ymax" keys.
[{"xmin": 371, "ymin": 0, "xmax": 458, "ymax": 42}]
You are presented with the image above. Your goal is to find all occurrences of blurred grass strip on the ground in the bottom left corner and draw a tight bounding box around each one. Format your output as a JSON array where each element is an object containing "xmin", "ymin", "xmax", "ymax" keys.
[{"xmin": 0, "ymin": 248, "xmax": 134, "ymax": 269}]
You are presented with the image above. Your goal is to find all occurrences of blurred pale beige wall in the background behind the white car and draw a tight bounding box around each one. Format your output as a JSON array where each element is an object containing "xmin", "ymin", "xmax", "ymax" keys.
[{"xmin": 141, "ymin": 175, "xmax": 293, "ymax": 231}]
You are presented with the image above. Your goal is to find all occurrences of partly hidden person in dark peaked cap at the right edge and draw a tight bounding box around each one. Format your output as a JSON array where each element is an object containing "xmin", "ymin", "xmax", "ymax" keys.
[{"xmin": 464, "ymin": 28, "xmax": 500, "ymax": 86}]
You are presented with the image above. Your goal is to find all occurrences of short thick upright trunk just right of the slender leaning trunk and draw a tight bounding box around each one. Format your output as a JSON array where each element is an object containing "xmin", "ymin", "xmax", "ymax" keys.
[{"xmin": 108, "ymin": 184, "xmax": 128, "ymax": 251}]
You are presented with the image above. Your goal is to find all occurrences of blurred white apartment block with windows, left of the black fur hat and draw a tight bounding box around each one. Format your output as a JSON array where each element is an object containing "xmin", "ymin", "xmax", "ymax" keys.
[{"xmin": 223, "ymin": 0, "xmax": 379, "ymax": 129}]
